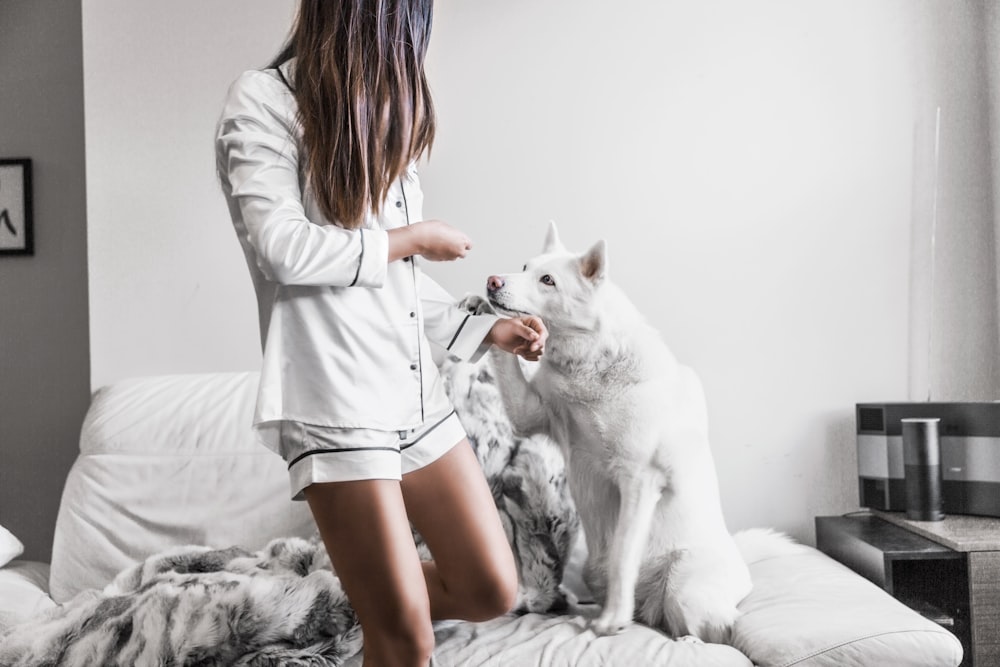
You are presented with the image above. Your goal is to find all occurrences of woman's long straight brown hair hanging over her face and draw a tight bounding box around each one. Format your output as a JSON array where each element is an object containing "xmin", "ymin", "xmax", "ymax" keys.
[{"xmin": 271, "ymin": 0, "xmax": 434, "ymax": 228}]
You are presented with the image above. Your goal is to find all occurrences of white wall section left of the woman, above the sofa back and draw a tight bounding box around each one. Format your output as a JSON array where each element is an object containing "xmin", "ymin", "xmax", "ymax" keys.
[{"xmin": 83, "ymin": 0, "xmax": 294, "ymax": 388}]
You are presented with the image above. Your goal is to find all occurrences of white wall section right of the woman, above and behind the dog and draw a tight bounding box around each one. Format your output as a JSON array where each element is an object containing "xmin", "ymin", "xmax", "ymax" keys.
[{"xmin": 424, "ymin": 0, "xmax": 997, "ymax": 537}]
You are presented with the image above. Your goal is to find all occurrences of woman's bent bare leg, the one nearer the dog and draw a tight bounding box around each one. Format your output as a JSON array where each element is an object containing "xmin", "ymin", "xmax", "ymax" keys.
[{"xmin": 400, "ymin": 440, "xmax": 517, "ymax": 621}]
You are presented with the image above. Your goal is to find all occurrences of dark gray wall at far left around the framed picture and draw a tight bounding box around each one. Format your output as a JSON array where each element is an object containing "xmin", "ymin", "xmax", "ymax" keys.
[{"xmin": 0, "ymin": 0, "xmax": 90, "ymax": 561}]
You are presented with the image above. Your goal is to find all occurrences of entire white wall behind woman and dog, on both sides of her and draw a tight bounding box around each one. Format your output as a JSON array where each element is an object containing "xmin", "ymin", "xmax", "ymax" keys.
[{"xmin": 83, "ymin": 0, "xmax": 997, "ymax": 540}]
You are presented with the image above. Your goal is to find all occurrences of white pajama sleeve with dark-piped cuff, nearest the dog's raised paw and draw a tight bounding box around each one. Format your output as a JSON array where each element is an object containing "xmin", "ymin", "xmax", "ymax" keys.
[{"xmin": 419, "ymin": 273, "xmax": 500, "ymax": 363}]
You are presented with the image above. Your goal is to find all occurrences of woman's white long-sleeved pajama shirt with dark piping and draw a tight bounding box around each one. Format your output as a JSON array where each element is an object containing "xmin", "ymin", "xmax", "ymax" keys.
[{"xmin": 216, "ymin": 61, "xmax": 496, "ymax": 451}]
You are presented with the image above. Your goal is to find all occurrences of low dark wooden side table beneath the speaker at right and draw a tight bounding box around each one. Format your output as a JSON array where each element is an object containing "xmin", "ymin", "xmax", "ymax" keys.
[{"xmin": 816, "ymin": 511, "xmax": 1000, "ymax": 667}]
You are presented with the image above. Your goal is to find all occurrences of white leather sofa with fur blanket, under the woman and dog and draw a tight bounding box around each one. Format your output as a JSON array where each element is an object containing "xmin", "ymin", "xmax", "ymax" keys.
[{"xmin": 0, "ymin": 365, "xmax": 962, "ymax": 667}]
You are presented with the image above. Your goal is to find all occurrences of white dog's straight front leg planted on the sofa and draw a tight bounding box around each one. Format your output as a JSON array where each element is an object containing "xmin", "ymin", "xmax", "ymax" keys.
[{"xmin": 593, "ymin": 476, "xmax": 663, "ymax": 635}]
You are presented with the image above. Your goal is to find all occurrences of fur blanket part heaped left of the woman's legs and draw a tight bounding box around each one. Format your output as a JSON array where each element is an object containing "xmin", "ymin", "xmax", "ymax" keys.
[{"xmin": 0, "ymin": 538, "xmax": 361, "ymax": 667}]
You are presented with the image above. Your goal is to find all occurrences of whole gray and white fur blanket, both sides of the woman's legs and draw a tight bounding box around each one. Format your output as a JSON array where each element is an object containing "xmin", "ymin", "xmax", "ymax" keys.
[{"xmin": 0, "ymin": 352, "xmax": 578, "ymax": 667}]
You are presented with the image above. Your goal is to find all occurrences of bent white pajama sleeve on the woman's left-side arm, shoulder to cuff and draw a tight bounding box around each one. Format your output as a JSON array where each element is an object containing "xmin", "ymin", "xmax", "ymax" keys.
[{"xmin": 215, "ymin": 72, "xmax": 389, "ymax": 287}]
